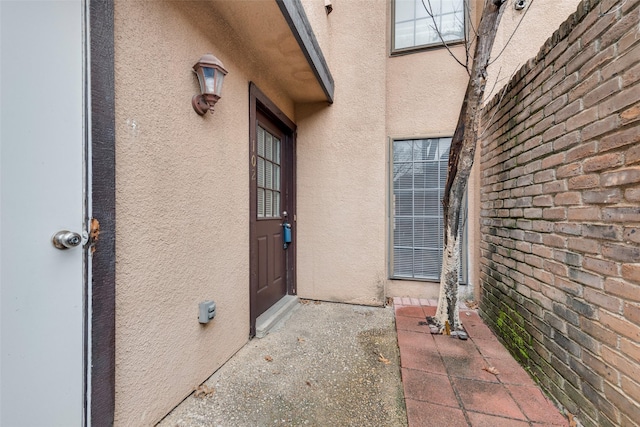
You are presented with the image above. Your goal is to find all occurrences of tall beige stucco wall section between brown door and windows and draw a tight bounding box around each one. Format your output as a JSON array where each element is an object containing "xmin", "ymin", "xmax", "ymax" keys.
[{"xmin": 296, "ymin": 0, "xmax": 387, "ymax": 304}]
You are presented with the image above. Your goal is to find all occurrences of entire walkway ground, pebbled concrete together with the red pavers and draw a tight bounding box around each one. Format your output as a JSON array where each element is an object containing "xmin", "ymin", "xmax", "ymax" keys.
[{"xmin": 159, "ymin": 298, "xmax": 569, "ymax": 427}]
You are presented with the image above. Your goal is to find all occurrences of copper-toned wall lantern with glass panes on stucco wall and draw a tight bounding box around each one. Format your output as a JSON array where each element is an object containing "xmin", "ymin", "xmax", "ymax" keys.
[{"xmin": 191, "ymin": 53, "xmax": 227, "ymax": 116}]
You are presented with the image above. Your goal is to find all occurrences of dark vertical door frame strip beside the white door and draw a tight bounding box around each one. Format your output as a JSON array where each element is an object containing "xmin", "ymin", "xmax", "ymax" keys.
[{"xmin": 84, "ymin": 0, "xmax": 116, "ymax": 426}]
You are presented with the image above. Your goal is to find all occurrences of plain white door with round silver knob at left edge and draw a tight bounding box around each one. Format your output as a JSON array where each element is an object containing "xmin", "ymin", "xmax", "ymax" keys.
[{"xmin": 0, "ymin": 0, "xmax": 85, "ymax": 427}]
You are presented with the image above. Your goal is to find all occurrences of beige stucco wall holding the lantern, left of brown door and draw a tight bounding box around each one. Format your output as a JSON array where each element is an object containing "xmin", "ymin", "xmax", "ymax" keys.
[{"xmin": 115, "ymin": 0, "xmax": 293, "ymax": 425}]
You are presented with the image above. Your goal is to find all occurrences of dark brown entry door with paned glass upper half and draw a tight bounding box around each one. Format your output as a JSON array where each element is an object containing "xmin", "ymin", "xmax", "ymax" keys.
[{"xmin": 250, "ymin": 85, "xmax": 295, "ymax": 335}]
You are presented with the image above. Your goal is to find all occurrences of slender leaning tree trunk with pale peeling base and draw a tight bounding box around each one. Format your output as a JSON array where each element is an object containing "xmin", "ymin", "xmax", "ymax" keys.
[{"xmin": 432, "ymin": 0, "xmax": 506, "ymax": 333}]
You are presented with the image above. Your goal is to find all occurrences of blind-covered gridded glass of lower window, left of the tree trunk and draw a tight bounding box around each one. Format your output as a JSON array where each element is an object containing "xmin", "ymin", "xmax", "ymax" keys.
[{"xmin": 391, "ymin": 138, "xmax": 451, "ymax": 280}]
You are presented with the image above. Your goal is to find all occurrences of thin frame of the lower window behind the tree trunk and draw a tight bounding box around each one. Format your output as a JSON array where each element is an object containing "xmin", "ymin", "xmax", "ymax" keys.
[{"xmin": 387, "ymin": 135, "xmax": 468, "ymax": 285}]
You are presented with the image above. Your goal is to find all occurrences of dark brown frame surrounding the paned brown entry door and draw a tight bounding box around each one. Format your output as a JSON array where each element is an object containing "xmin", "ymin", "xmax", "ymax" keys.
[{"xmin": 248, "ymin": 82, "xmax": 297, "ymax": 337}]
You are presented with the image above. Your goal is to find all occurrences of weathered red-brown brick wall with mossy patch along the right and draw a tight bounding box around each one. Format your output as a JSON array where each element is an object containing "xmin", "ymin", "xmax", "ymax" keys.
[{"xmin": 480, "ymin": 0, "xmax": 640, "ymax": 426}]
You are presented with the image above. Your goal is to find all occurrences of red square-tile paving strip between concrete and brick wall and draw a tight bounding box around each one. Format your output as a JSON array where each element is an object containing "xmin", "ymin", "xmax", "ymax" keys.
[{"xmin": 394, "ymin": 298, "xmax": 569, "ymax": 427}]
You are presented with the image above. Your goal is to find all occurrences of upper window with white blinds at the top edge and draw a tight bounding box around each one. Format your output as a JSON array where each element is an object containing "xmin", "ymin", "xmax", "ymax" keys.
[{"xmin": 393, "ymin": 0, "xmax": 465, "ymax": 51}]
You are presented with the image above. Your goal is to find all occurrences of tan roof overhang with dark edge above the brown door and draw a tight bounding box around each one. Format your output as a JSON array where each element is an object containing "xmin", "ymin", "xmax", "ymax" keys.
[{"xmin": 211, "ymin": 0, "xmax": 334, "ymax": 103}]
